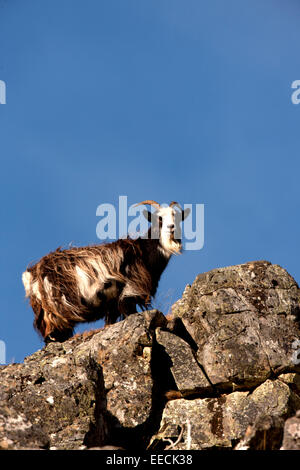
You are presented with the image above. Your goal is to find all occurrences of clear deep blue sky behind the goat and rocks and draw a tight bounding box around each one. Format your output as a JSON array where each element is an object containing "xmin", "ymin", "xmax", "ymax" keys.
[{"xmin": 0, "ymin": 0, "xmax": 300, "ymax": 362}]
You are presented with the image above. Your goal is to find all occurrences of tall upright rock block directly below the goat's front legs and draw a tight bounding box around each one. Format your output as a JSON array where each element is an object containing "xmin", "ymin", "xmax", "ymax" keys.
[{"xmin": 84, "ymin": 310, "xmax": 167, "ymax": 445}]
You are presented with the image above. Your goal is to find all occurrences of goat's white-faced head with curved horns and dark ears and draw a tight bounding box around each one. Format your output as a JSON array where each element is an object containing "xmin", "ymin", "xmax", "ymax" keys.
[{"xmin": 136, "ymin": 200, "xmax": 190, "ymax": 255}]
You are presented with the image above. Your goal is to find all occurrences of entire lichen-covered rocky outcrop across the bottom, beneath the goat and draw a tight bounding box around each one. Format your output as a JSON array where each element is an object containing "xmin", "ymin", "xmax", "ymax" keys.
[{"xmin": 0, "ymin": 261, "xmax": 300, "ymax": 451}]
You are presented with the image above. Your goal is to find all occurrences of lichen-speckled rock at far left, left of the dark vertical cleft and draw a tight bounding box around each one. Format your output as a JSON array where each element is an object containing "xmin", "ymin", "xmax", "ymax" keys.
[{"xmin": 0, "ymin": 343, "xmax": 107, "ymax": 449}]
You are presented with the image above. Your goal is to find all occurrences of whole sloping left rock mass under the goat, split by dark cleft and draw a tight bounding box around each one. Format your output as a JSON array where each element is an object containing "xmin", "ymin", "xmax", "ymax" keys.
[{"xmin": 0, "ymin": 311, "xmax": 166, "ymax": 449}]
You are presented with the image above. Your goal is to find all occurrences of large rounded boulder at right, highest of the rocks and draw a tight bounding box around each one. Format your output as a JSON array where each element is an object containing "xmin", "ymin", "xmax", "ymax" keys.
[{"xmin": 172, "ymin": 261, "xmax": 300, "ymax": 391}]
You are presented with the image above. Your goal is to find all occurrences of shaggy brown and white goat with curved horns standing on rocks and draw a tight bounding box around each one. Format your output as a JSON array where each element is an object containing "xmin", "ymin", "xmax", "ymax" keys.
[{"xmin": 22, "ymin": 200, "xmax": 190, "ymax": 343}]
